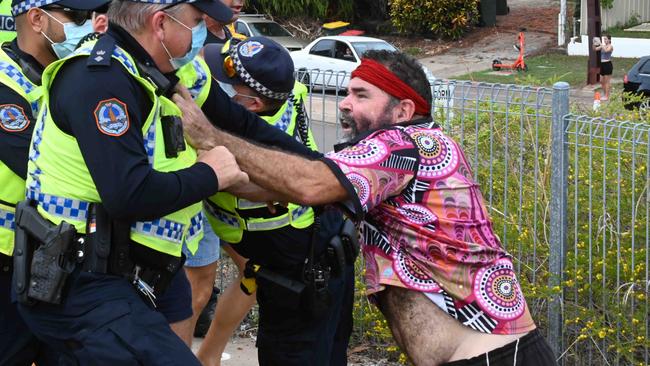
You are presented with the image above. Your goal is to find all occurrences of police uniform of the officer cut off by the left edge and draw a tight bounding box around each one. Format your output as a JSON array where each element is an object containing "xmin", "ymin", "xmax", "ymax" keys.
[{"xmin": 0, "ymin": 35, "xmax": 43, "ymax": 365}]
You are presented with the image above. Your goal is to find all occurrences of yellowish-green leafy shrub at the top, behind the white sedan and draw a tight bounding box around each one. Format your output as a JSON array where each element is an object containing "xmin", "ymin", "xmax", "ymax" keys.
[{"xmin": 390, "ymin": 0, "xmax": 479, "ymax": 39}]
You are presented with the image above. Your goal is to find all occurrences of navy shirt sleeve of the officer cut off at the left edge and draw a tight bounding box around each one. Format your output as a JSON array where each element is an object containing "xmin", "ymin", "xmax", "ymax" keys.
[{"xmin": 0, "ymin": 39, "xmax": 43, "ymax": 179}]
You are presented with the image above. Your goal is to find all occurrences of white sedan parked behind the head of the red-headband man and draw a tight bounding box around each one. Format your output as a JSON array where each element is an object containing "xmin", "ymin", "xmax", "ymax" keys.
[{"xmin": 291, "ymin": 36, "xmax": 435, "ymax": 89}]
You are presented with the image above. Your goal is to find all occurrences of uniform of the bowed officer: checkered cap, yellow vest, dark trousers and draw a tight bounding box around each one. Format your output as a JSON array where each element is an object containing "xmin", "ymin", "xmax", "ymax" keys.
[{"xmin": 204, "ymin": 37, "xmax": 354, "ymax": 365}]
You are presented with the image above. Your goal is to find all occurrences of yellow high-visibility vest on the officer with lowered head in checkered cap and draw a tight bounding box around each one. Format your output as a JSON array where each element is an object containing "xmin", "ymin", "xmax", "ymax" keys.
[{"xmin": 204, "ymin": 82, "xmax": 318, "ymax": 243}]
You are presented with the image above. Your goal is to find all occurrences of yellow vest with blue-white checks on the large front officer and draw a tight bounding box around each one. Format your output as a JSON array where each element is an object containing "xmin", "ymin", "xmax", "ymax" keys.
[{"xmin": 27, "ymin": 41, "xmax": 207, "ymax": 257}]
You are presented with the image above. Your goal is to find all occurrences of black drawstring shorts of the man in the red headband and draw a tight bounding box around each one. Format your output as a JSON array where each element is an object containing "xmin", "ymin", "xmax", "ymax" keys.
[{"xmin": 443, "ymin": 329, "xmax": 557, "ymax": 366}]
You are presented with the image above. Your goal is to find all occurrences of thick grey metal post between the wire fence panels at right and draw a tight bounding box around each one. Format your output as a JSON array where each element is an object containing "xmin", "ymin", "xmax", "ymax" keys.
[{"xmin": 548, "ymin": 82, "xmax": 569, "ymax": 364}]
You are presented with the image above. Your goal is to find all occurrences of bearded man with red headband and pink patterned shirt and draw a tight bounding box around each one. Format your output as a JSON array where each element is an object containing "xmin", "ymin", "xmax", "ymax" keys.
[{"xmin": 175, "ymin": 51, "xmax": 555, "ymax": 365}]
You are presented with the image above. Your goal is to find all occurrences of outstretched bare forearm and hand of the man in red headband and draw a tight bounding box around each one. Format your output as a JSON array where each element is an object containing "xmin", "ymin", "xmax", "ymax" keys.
[{"xmin": 173, "ymin": 86, "xmax": 348, "ymax": 206}]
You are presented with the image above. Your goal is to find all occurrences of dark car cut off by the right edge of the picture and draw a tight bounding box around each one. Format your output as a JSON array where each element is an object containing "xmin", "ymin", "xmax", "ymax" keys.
[{"xmin": 623, "ymin": 56, "xmax": 650, "ymax": 113}]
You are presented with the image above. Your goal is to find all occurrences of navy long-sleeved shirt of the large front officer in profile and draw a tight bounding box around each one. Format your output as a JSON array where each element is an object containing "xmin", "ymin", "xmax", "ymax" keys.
[{"xmin": 50, "ymin": 24, "xmax": 320, "ymax": 220}]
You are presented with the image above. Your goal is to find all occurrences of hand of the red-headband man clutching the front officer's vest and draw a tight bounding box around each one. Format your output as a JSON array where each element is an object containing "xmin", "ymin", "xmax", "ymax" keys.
[{"xmin": 172, "ymin": 84, "xmax": 216, "ymax": 150}]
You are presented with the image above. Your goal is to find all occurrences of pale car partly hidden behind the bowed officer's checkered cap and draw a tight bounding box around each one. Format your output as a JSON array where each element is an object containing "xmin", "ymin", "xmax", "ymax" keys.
[{"xmin": 235, "ymin": 14, "xmax": 307, "ymax": 52}]
